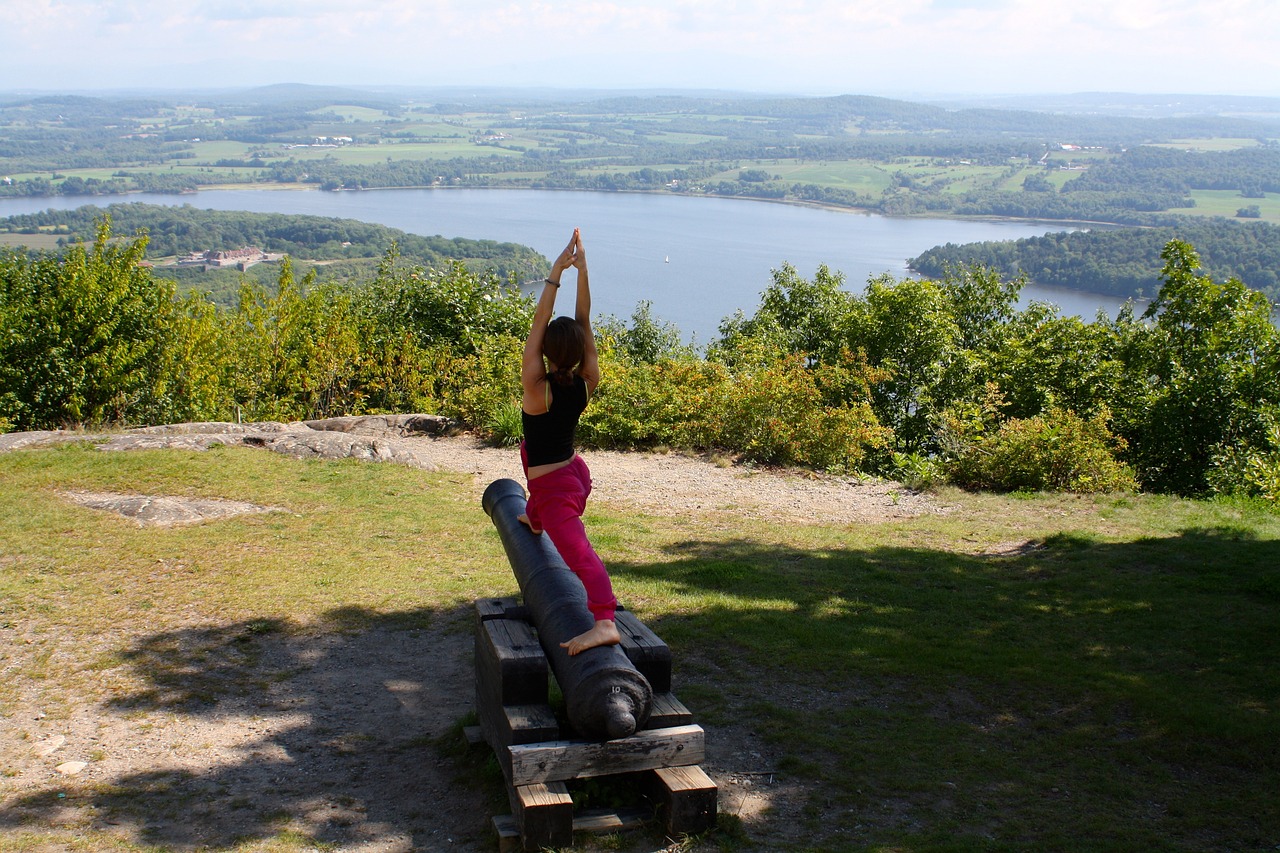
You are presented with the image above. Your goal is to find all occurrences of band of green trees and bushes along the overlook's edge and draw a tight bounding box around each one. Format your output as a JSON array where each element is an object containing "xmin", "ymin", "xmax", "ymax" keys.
[{"xmin": 0, "ymin": 222, "xmax": 1280, "ymax": 501}]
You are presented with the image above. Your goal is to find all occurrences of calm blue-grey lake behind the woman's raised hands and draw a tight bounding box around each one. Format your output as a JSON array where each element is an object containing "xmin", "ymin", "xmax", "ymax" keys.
[{"xmin": 0, "ymin": 190, "xmax": 1136, "ymax": 343}]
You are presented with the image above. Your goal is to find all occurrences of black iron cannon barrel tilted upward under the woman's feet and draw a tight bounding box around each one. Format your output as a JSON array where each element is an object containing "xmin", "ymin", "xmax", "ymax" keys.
[{"xmin": 481, "ymin": 479, "xmax": 653, "ymax": 739}]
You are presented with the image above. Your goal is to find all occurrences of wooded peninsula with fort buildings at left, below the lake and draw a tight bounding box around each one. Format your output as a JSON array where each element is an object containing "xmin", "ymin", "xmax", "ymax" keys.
[{"xmin": 0, "ymin": 202, "xmax": 547, "ymax": 279}]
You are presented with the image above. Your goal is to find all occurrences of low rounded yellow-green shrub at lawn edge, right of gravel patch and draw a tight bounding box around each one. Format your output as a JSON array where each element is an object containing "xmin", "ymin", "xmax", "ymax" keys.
[{"xmin": 947, "ymin": 409, "xmax": 1137, "ymax": 493}]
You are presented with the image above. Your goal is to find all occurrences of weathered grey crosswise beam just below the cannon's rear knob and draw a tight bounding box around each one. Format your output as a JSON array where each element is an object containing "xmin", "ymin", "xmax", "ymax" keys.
[{"xmin": 507, "ymin": 725, "xmax": 707, "ymax": 785}]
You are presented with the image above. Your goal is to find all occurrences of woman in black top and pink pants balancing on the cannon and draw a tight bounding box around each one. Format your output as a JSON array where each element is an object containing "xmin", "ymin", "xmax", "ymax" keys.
[{"xmin": 520, "ymin": 228, "xmax": 621, "ymax": 654}]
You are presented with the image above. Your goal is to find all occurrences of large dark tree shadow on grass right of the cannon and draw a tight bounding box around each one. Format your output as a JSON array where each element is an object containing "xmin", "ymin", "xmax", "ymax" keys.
[{"xmin": 613, "ymin": 528, "xmax": 1280, "ymax": 850}]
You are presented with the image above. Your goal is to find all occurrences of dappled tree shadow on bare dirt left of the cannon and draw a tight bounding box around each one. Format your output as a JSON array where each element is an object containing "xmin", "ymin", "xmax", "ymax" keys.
[{"xmin": 0, "ymin": 608, "xmax": 490, "ymax": 850}]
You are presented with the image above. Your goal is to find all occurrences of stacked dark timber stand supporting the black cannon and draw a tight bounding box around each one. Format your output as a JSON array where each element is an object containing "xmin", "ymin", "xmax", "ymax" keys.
[{"xmin": 475, "ymin": 598, "xmax": 717, "ymax": 853}]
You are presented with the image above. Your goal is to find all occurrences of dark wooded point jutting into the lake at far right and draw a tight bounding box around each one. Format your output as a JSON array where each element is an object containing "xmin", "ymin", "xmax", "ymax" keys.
[{"xmin": 910, "ymin": 216, "xmax": 1280, "ymax": 300}]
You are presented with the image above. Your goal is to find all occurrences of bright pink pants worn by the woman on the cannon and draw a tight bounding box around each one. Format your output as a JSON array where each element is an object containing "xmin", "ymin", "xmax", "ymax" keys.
[{"xmin": 520, "ymin": 444, "xmax": 618, "ymax": 621}]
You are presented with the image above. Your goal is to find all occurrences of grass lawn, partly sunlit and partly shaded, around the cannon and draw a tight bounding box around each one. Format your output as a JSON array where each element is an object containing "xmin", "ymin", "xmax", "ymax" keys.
[{"xmin": 0, "ymin": 446, "xmax": 1280, "ymax": 853}]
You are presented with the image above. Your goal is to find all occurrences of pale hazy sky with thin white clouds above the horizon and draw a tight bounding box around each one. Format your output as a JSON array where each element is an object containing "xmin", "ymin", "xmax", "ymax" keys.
[{"xmin": 0, "ymin": 0, "xmax": 1280, "ymax": 97}]
